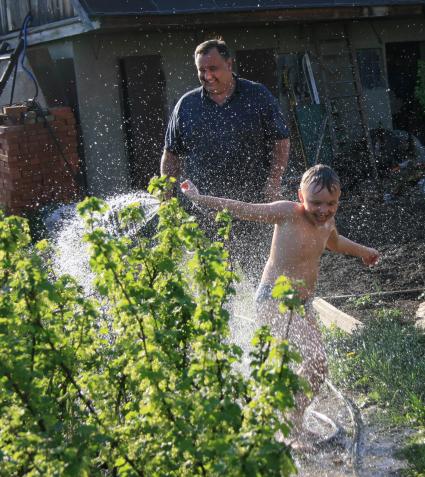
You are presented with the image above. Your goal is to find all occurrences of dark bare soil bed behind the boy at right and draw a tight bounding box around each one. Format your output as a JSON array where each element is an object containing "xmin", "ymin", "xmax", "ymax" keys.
[{"xmin": 317, "ymin": 172, "xmax": 425, "ymax": 318}]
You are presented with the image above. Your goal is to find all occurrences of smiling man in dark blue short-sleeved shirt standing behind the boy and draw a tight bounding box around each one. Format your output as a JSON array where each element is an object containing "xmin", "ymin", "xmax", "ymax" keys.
[{"xmin": 161, "ymin": 40, "xmax": 289, "ymax": 275}]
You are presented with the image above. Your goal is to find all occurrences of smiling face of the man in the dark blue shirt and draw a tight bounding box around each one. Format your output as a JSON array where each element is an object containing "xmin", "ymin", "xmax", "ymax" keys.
[{"xmin": 195, "ymin": 48, "xmax": 233, "ymax": 94}]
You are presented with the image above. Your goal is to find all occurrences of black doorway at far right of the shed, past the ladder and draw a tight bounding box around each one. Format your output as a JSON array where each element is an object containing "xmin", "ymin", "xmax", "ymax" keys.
[{"xmin": 386, "ymin": 41, "xmax": 425, "ymax": 142}]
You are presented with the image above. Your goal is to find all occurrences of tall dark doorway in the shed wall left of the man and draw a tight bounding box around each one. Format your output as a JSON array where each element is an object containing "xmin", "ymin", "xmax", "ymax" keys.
[{"xmin": 120, "ymin": 55, "xmax": 165, "ymax": 189}]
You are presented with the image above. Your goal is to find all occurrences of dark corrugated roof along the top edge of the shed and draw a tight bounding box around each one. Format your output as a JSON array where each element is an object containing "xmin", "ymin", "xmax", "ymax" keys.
[{"xmin": 79, "ymin": 0, "xmax": 425, "ymax": 16}]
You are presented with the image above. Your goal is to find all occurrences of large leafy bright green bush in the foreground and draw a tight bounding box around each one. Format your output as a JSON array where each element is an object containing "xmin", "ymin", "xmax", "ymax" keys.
[{"xmin": 0, "ymin": 180, "xmax": 305, "ymax": 477}]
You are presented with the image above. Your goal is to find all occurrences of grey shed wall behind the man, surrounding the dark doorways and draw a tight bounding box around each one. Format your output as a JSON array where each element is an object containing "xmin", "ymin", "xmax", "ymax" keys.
[{"xmin": 68, "ymin": 18, "xmax": 425, "ymax": 195}]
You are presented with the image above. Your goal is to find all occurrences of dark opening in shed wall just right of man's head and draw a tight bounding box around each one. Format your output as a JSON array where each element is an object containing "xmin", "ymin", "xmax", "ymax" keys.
[{"xmin": 236, "ymin": 49, "xmax": 278, "ymax": 97}]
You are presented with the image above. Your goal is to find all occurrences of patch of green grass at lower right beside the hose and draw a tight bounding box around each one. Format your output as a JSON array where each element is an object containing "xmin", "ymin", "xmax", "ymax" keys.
[{"xmin": 324, "ymin": 309, "xmax": 425, "ymax": 426}]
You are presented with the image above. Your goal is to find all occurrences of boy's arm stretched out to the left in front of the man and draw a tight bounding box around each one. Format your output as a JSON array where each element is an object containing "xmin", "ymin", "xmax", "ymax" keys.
[{"xmin": 180, "ymin": 180, "xmax": 296, "ymax": 224}]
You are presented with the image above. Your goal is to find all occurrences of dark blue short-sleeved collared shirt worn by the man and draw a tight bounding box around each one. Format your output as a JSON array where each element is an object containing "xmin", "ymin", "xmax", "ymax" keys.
[{"xmin": 165, "ymin": 78, "xmax": 288, "ymax": 201}]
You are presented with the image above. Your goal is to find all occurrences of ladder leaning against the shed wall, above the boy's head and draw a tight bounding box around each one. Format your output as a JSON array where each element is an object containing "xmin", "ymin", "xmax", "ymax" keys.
[{"xmin": 313, "ymin": 25, "xmax": 377, "ymax": 178}]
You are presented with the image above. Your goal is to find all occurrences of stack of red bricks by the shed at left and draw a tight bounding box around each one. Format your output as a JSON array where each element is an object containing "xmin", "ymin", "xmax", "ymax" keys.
[{"xmin": 0, "ymin": 107, "xmax": 80, "ymax": 214}]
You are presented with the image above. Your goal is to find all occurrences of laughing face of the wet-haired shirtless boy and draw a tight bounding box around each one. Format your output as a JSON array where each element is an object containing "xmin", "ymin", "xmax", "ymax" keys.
[{"xmin": 298, "ymin": 183, "xmax": 341, "ymax": 225}]
